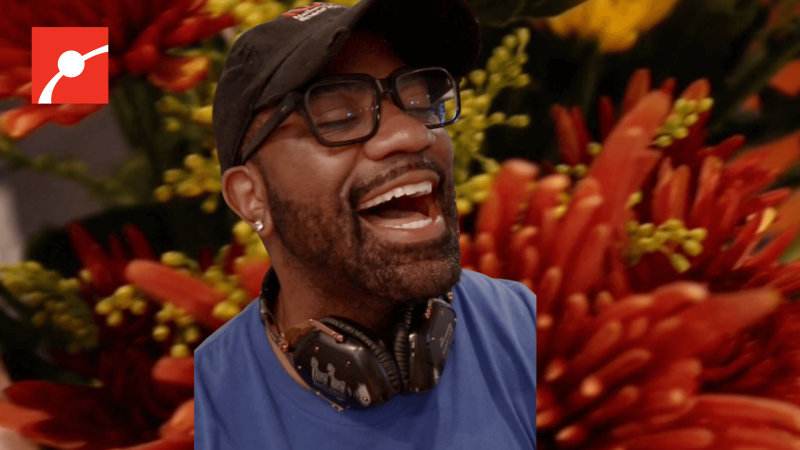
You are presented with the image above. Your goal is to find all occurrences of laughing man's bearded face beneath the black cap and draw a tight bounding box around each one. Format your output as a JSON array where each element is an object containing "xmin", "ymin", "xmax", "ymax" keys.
[{"xmin": 256, "ymin": 32, "xmax": 461, "ymax": 304}]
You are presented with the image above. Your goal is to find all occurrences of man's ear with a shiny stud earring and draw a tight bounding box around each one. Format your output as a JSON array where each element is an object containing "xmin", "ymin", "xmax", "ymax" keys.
[{"xmin": 222, "ymin": 161, "xmax": 273, "ymax": 238}]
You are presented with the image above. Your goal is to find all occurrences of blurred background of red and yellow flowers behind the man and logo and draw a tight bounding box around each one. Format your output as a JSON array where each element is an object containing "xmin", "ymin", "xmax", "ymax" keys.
[{"xmin": 0, "ymin": 0, "xmax": 800, "ymax": 450}]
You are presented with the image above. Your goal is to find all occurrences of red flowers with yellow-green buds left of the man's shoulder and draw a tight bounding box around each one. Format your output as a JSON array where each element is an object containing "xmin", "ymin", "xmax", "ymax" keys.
[{"xmin": 0, "ymin": 216, "xmax": 270, "ymax": 450}]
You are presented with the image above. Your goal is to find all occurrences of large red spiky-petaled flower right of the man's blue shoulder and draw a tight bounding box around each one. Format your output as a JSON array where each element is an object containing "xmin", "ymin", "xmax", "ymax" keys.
[{"xmin": 461, "ymin": 68, "xmax": 800, "ymax": 450}]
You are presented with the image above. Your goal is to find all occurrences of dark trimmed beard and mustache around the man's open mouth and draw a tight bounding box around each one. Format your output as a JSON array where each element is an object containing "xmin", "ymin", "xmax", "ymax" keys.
[{"xmin": 265, "ymin": 158, "xmax": 461, "ymax": 309}]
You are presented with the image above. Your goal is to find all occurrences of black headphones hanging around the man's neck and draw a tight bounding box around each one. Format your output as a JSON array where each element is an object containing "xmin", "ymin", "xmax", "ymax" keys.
[{"xmin": 259, "ymin": 267, "xmax": 456, "ymax": 411}]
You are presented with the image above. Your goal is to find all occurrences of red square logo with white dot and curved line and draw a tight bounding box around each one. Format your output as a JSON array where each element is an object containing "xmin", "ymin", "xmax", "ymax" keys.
[{"xmin": 31, "ymin": 27, "xmax": 108, "ymax": 104}]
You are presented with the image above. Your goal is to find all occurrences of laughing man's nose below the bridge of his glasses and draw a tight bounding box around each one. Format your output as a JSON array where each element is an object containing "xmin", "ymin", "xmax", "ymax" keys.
[{"xmin": 363, "ymin": 97, "xmax": 436, "ymax": 161}]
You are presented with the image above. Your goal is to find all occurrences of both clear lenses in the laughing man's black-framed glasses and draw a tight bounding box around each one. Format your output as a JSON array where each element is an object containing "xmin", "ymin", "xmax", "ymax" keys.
[{"xmin": 307, "ymin": 69, "xmax": 456, "ymax": 143}]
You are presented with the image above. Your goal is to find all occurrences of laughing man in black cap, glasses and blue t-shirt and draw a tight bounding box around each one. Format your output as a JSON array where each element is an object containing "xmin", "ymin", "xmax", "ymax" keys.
[{"xmin": 195, "ymin": 0, "xmax": 536, "ymax": 450}]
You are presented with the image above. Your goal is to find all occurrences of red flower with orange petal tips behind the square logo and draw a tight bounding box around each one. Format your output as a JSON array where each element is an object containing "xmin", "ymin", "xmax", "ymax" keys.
[{"xmin": 0, "ymin": 0, "xmax": 234, "ymax": 139}]
